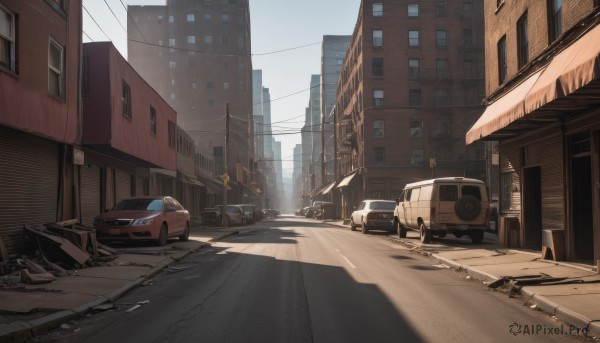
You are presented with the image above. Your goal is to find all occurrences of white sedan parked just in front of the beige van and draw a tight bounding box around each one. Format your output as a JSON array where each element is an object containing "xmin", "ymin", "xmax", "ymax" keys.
[{"xmin": 350, "ymin": 200, "xmax": 396, "ymax": 233}]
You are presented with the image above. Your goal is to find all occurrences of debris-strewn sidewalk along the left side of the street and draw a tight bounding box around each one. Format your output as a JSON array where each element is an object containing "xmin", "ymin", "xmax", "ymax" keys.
[{"xmin": 0, "ymin": 226, "xmax": 247, "ymax": 342}]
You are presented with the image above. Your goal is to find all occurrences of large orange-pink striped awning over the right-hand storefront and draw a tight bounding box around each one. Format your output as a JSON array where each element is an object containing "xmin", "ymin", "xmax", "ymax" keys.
[{"xmin": 466, "ymin": 25, "xmax": 600, "ymax": 144}]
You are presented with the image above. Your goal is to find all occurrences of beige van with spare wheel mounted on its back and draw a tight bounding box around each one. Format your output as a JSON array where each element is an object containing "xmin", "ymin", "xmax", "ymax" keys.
[{"xmin": 394, "ymin": 177, "xmax": 490, "ymax": 244}]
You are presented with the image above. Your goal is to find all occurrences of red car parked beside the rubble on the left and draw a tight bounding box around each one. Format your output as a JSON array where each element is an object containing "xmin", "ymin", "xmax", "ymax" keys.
[{"xmin": 94, "ymin": 196, "xmax": 190, "ymax": 246}]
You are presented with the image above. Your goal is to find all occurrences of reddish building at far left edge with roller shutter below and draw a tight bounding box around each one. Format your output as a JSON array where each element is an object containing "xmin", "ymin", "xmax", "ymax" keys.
[{"xmin": 0, "ymin": 0, "xmax": 83, "ymax": 254}]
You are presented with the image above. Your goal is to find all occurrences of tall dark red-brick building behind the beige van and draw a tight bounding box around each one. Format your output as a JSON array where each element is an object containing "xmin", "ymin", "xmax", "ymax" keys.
[{"xmin": 335, "ymin": 0, "xmax": 485, "ymax": 218}]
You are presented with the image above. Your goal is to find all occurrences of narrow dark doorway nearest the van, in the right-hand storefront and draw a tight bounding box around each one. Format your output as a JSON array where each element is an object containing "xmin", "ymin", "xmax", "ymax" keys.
[{"xmin": 523, "ymin": 167, "xmax": 542, "ymax": 250}]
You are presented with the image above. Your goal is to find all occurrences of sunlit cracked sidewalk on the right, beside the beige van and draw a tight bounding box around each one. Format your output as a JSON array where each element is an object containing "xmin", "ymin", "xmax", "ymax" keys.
[{"xmin": 325, "ymin": 220, "xmax": 600, "ymax": 337}]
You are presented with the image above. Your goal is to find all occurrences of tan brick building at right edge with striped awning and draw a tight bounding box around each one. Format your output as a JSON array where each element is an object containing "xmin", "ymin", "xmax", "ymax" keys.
[{"xmin": 466, "ymin": 0, "xmax": 600, "ymax": 264}]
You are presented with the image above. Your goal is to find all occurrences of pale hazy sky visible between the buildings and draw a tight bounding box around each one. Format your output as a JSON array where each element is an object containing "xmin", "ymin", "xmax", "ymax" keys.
[{"xmin": 83, "ymin": 0, "xmax": 360, "ymax": 177}]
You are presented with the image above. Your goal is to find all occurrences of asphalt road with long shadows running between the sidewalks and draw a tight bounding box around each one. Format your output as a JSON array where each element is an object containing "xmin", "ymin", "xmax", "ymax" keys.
[{"xmin": 34, "ymin": 218, "xmax": 581, "ymax": 343}]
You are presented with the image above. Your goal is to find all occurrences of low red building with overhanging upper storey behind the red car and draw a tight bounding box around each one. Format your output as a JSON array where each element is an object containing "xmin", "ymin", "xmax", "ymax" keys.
[{"xmin": 80, "ymin": 42, "xmax": 177, "ymax": 226}]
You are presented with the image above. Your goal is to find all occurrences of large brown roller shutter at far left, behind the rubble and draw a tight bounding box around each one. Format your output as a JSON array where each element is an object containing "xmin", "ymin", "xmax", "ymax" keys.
[{"xmin": 0, "ymin": 127, "xmax": 59, "ymax": 254}]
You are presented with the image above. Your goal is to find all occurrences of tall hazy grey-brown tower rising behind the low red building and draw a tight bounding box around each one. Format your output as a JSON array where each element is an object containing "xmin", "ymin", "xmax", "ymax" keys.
[{"xmin": 127, "ymin": 0, "xmax": 257, "ymax": 203}]
